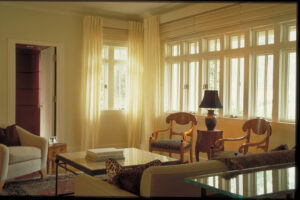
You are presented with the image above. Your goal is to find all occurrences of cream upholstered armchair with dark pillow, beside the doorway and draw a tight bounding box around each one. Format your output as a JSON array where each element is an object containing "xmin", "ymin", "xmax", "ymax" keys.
[{"xmin": 0, "ymin": 126, "xmax": 48, "ymax": 192}]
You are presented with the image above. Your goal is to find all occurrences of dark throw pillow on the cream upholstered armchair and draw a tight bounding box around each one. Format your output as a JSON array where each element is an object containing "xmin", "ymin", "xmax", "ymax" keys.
[{"xmin": 0, "ymin": 124, "xmax": 21, "ymax": 146}]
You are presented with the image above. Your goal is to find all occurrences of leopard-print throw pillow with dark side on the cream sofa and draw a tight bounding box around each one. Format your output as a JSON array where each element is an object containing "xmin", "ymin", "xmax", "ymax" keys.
[{"xmin": 105, "ymin": 158, "xmax": 161, "ymax": 195}]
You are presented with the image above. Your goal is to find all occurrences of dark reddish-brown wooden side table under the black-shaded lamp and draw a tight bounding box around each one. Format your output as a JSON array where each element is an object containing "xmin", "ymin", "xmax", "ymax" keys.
[{"xmin": 195, "ymin": 130, "xmax": 223, "ymax": 161}]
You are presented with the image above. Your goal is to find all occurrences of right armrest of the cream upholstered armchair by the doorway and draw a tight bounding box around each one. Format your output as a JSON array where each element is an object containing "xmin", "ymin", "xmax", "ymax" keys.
[{"xmin": 16, "ymin": 126, "xmax": 48, "ymax": 169}]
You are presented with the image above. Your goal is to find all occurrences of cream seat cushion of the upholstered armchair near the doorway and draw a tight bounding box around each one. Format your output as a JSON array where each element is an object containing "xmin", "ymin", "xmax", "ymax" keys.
[{"xmin": 8, "ymin": 146, "xmax": 42, "ymax": 164}]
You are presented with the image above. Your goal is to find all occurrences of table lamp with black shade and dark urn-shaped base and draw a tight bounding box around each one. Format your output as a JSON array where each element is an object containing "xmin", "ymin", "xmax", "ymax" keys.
[{"xmin": 199, "ymin": 90, "xmax": 223, "ymax": 130}]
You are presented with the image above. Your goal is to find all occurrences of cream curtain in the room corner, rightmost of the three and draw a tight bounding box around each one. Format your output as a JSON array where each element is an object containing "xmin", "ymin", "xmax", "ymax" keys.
[{"xmin": 142, "ymin": 16, "xmax": 163, "ymax": 148}]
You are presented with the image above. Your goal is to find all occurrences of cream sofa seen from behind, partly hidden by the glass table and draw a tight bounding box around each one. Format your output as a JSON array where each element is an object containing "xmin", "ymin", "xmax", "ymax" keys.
[{"xmin": 75, "ymin": 150, "xmax": 295, "ymax": 197}]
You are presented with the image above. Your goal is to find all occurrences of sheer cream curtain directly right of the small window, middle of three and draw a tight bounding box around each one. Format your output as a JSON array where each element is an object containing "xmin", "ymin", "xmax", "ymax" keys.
[{"xmin": 126, "ymin": 21, "xmax": 144, "ymax": 148}]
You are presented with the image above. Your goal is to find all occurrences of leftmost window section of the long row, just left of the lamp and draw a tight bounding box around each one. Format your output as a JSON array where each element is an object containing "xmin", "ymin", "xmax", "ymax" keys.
[{"xmin": 164, "ymin": 41, "xmax": 199, "ymax": 112}]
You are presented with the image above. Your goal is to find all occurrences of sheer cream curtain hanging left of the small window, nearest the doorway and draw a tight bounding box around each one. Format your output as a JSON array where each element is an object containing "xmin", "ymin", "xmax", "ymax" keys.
[{"xmin": 81, "ymin": 16, "xmax": 103, "ymax": 150}]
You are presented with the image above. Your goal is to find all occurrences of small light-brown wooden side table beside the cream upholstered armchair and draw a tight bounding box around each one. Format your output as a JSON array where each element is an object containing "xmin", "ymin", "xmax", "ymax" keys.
[{"xmin": 47, "ymin": 143, "xmax": 67, "ymax": 173}]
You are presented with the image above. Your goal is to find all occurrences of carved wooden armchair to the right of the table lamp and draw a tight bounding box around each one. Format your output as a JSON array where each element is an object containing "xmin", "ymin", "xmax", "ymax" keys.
[{"xmin": 209, "ymin": 118, "xmax": 272, "ymax": 159}]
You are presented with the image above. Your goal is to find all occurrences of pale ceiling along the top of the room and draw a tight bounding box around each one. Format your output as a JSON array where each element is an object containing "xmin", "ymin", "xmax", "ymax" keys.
[{"xmin": 0, "ymin": 1, "xmax": 194, "ymax": 20}]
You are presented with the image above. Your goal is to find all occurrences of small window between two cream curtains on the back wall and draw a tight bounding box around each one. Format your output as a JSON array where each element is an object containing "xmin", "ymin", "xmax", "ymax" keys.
[{"xmin": 100, "ymin": 46, "xmax": 128, "ymax": 110}]
